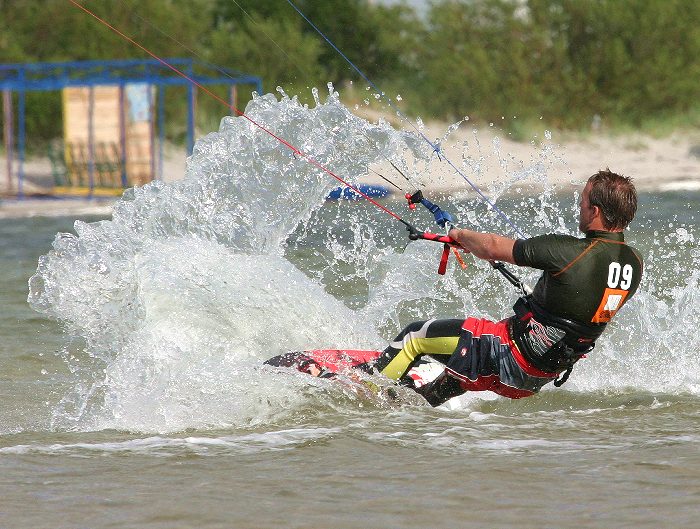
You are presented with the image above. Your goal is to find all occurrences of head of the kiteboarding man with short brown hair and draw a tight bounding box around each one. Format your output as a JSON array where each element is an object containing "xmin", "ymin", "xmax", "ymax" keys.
[{"xmin": 579, "ymin": 169, "xmax": 637, "ymax": 232}]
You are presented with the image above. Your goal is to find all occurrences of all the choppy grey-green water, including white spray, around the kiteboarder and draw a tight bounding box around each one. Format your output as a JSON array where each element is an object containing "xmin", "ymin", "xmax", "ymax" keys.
[{"xmin": 0, "ymin": 88, "xmax": 700, "ymax": 528}]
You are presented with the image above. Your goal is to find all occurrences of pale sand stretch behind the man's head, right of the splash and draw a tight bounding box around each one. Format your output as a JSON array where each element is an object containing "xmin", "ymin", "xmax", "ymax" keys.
[{"xmin": 366, "ymin": 117, "xmax": 700, "ymax": 192}]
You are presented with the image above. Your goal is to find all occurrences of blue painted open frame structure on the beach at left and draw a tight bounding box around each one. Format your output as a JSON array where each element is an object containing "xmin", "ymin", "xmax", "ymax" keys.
[{"xmin": 0, "ymin": 58, "xmax": 262, "ymax": 197}]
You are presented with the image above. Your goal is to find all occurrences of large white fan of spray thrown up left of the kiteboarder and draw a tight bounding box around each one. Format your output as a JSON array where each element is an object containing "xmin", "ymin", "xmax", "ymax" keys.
[{"xmin": 29, "ymin": 90, "xmax": 430, "ymax": 430}]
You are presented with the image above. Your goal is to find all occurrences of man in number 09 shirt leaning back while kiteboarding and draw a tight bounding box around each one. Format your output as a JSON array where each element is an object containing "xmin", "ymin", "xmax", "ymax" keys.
[{"xmin": 372, "ymin": 169, "xmax": 643, "ymax": 406}]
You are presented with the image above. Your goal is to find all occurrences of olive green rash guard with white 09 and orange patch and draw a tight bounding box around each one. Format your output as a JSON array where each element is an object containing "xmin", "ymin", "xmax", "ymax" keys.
[{"xmin": 513, "ymin": 231, "xmax": 644, "ymax": 329}]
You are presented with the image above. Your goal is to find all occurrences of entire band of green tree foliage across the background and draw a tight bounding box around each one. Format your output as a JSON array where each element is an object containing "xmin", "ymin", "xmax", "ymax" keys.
[{"xmin": 0, "ymin": 0, "xmax": 700, "ymax": 144}]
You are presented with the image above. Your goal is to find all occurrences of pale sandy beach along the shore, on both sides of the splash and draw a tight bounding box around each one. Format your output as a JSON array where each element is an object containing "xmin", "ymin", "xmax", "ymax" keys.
[{"xmin": 0, "ymin": 123, "xmax": 700, "ymax": 218}]
